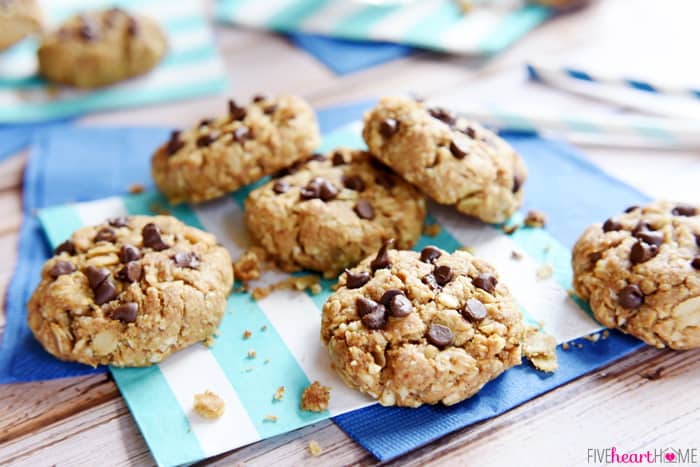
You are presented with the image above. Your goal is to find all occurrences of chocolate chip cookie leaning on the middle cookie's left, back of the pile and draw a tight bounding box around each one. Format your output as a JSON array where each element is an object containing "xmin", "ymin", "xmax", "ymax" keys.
[{"xmin": 152, "ymin": 96, "xmax": 320, "ymax": 203}]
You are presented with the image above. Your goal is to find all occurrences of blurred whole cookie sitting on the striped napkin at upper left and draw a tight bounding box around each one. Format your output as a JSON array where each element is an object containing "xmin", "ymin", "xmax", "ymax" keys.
[{"xmin": 38, "ymin": 8, "xmax": 167, "ymax": 88}]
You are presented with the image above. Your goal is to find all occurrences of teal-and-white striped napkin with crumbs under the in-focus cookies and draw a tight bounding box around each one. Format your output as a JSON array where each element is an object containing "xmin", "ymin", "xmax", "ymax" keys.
[{"xmin": 39, "ymin": 123, "xmax": 600, "ymax": 465}]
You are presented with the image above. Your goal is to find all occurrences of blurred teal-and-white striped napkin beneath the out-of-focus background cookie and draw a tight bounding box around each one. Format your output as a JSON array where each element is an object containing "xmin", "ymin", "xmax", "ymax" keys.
[{"xmin": 0, "ymin": 0, "xmax": 228, "ymax": 124}]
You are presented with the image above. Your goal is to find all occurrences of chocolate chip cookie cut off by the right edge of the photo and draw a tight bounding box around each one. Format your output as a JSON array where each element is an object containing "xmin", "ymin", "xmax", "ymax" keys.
[{"xmin": 572, "ymin": 201, "xmax": 700, "ymax": 349}]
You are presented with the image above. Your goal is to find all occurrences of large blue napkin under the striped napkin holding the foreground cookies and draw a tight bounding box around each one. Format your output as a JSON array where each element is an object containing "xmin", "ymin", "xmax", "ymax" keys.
[{"xmin": 0, "ymin": 101, "xmax": 647, "ymax": 461}]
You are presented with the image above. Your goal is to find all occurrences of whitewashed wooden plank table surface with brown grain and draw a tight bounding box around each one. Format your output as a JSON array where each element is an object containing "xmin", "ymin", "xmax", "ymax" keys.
[{"xmin": 0, "ymin": 0, "xmax": 700, "ymax": 466}]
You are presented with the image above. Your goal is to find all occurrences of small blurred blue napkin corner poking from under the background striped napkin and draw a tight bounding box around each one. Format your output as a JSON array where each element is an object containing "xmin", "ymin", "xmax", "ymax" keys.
[{"xmin": 289, "ymin": 34, "xmax": 413, "ymax": 75}]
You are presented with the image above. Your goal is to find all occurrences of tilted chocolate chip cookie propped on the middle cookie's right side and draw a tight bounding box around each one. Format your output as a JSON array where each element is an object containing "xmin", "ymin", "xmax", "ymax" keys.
[{"xmin": 363, "ymin": 97, "xmax": 527, "ymax": 223}]
